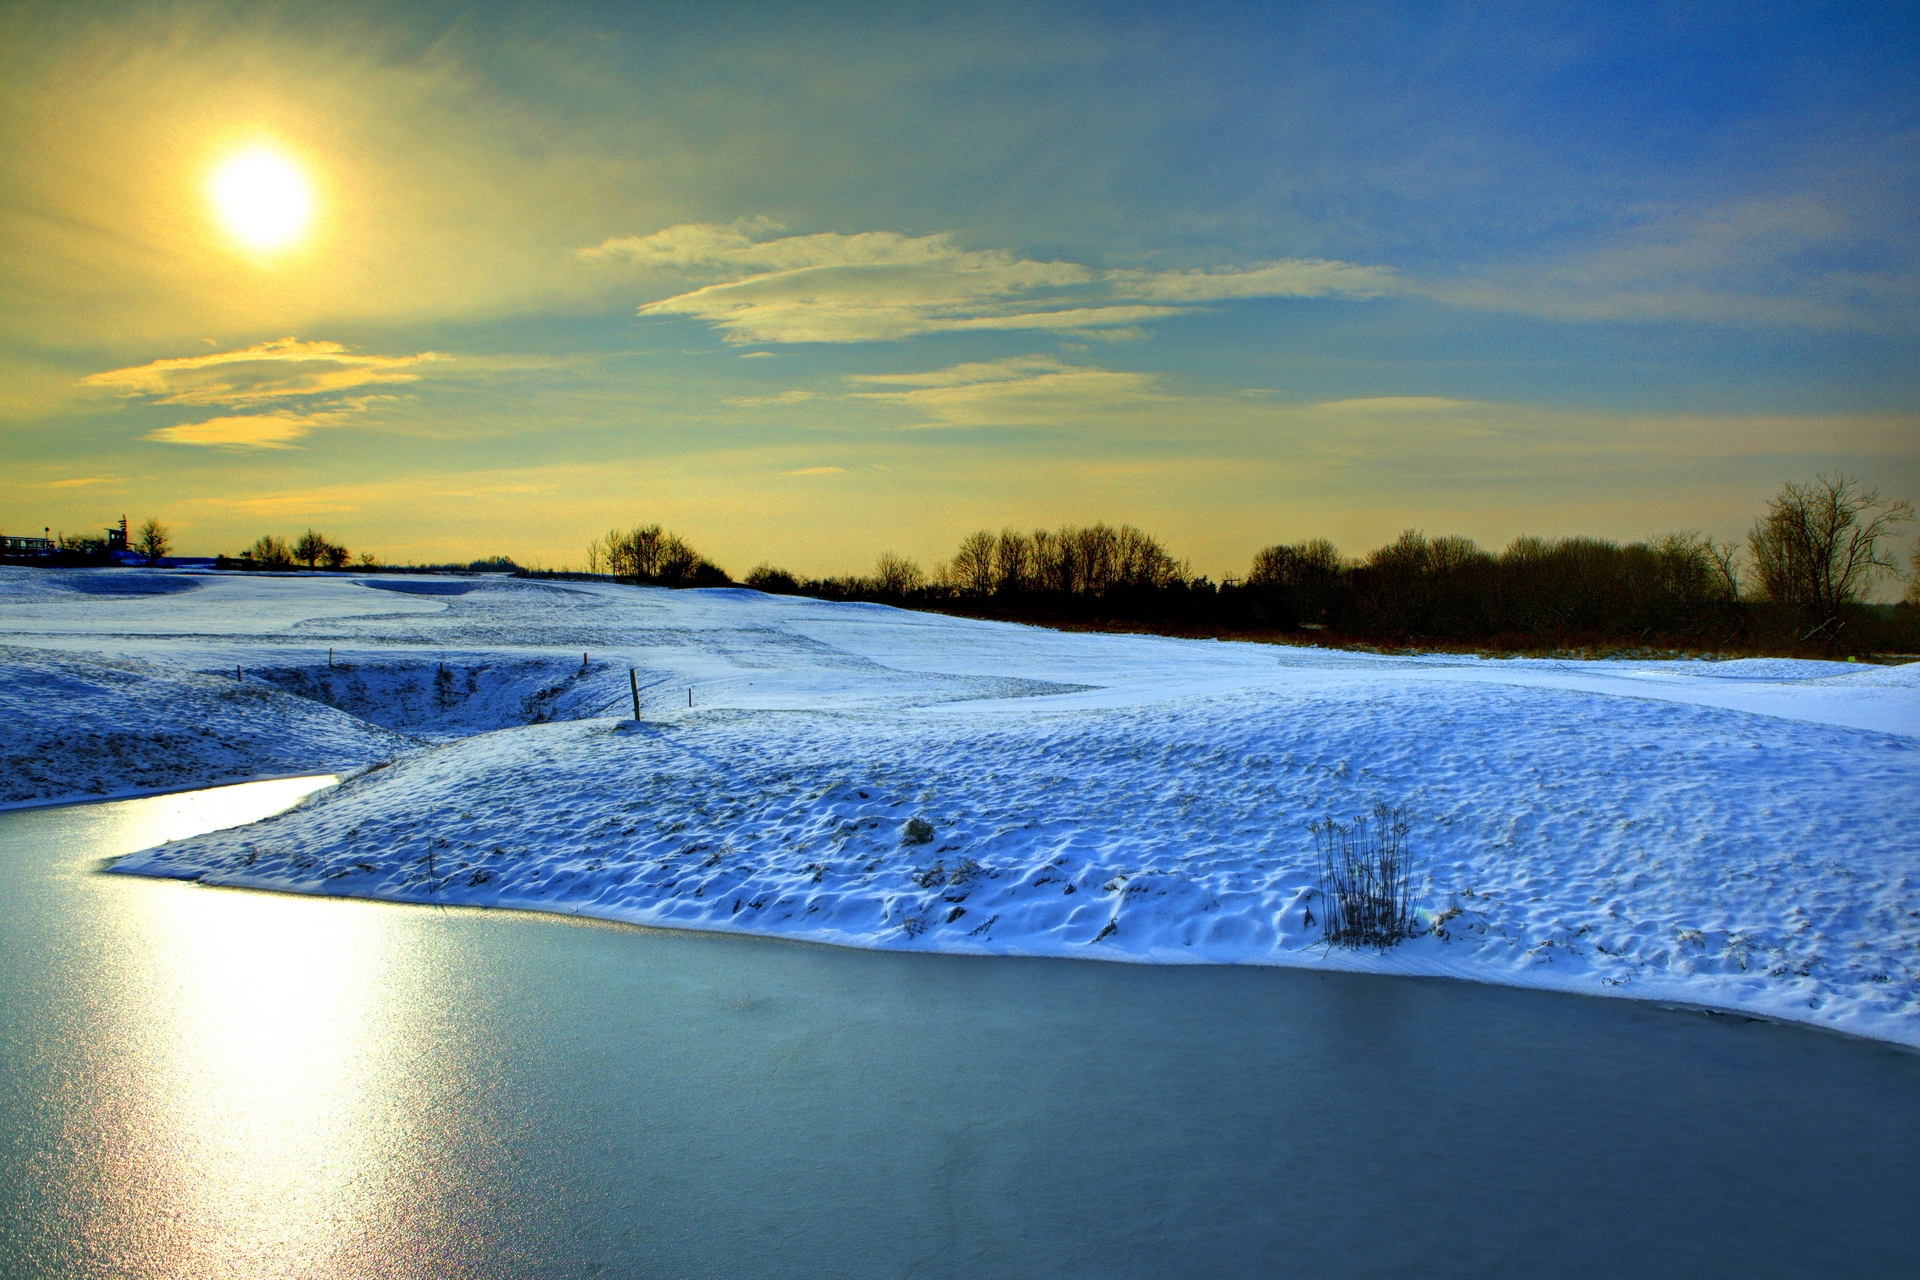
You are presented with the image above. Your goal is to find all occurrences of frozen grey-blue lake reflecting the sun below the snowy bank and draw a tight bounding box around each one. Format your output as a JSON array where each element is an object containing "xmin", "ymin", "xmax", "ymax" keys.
[{"xmin": 0, "ymin": 783, "xmax": 1920, "ymax": 1280}]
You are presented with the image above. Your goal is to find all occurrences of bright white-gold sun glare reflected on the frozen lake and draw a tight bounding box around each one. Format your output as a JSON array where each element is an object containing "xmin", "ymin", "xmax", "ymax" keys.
[{"xmin": 79, "ymin": 783, "xmax": 476, "ymax": 1280}]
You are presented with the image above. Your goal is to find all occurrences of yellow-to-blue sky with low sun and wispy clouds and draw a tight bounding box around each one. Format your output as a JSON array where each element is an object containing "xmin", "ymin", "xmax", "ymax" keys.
[{"xmin": 0, "ymin": 4, "xmax": 1920, "ymax": 578}]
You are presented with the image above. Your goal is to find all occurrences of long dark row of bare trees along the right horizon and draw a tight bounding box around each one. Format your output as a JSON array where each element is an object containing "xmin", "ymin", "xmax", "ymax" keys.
[{"xmin": 560, "ymin": 474, "xmax": 1920, "ymax": 652}]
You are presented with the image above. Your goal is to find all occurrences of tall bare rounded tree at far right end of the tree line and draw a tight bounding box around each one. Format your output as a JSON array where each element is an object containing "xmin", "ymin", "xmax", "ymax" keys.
[{"xmin": 1747, "ymin": 472, "xmax": 1912, "ymax": 639}]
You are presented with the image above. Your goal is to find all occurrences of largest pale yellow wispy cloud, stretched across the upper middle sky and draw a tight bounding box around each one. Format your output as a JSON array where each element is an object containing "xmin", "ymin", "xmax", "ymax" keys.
[{"xmin": 580, "ymin": 219, "xmax": 1396, "ymax": 344}]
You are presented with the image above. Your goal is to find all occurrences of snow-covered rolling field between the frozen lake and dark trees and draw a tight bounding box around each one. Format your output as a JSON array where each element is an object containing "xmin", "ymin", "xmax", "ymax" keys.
[{"xmin": 11, "ymin": 570, "xmax": 1920, "ymax": 1046}]
